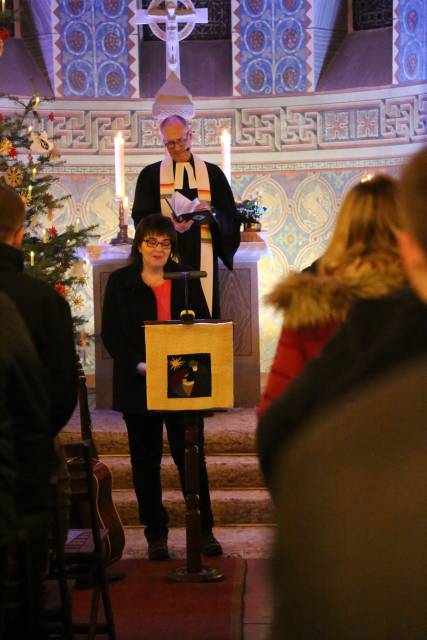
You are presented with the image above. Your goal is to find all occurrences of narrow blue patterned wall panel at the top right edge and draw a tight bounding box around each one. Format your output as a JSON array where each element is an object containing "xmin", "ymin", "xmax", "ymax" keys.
[{"xmin": 394, "ymin": 0, "xmax": 427, "ymax": 82}]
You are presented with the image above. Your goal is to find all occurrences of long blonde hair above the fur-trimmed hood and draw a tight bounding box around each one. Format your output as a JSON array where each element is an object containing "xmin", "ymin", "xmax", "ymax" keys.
[{"xmin": 320, "ymin": 175, "xmax": 400, "ymax": 271}]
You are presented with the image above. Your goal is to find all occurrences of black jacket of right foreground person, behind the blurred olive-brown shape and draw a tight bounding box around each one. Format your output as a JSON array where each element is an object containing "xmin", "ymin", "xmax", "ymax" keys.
[{"xmin": 257, "ymin": 289, "xmax": 427, "ymax": 491}]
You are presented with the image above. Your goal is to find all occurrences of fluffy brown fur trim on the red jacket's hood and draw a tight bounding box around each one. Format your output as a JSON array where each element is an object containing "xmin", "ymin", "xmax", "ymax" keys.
[{"xmin": 265, "ymin": 255, "xmax": 407, "ymax": 329}]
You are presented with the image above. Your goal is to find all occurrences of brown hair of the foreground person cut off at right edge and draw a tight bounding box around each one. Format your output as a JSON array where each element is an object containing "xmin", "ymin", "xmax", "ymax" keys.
[{"xmin": 400, "ymin": 148, "xmax": 427, "ymax": 253}]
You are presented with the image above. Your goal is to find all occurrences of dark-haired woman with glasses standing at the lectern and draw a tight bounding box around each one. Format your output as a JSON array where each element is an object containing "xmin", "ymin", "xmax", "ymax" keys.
[{"xmin": 102, "ymin": 214, "xmax": 222, "ymax": 560}]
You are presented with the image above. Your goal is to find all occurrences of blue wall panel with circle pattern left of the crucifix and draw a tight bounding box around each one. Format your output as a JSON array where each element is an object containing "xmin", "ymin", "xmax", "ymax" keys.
[{"xmin": 53, "ymin": 0, "xmax": 138, "ymax": 99}]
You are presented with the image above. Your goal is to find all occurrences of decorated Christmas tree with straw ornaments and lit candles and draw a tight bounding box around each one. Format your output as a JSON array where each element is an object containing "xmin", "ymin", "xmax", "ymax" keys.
[{"xmin": 0, "ymin": 94, "xmax": 95, "ymax": 327}]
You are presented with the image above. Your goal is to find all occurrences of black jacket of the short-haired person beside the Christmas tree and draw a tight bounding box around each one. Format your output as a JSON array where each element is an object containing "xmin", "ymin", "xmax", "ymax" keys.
[{"xmin": 0, "ymin": 244, "xmax": 77, "ymax": 434}]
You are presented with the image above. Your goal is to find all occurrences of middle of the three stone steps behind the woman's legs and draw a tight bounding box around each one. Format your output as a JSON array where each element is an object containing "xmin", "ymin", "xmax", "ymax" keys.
[{"xmin": 101, "ymin": 455, "xmax": 264, "ymax": 489}]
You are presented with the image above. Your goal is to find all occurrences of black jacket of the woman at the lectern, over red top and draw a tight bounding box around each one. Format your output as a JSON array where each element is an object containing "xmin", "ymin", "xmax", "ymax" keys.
[{"xmin": 101, "ymin": 262, "xmax": 209, "ymax": 413}]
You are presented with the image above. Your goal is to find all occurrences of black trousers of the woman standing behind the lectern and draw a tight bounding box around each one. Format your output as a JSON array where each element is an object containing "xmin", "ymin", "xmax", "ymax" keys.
[{"xmin": 123, "ymin": 411, "xmax": 213, "ymax": 540}]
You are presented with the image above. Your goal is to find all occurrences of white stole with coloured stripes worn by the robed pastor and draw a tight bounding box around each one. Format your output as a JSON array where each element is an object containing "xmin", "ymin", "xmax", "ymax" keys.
[{"xmin": 160, "ymin": 155, "xmax": 213, "ymax": 314}]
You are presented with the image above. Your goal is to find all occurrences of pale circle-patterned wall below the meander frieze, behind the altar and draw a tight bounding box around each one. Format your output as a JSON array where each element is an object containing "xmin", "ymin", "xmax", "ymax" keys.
[{"xmin": 46, "ymin": 158, "xmax": 401, "ymax": 372}]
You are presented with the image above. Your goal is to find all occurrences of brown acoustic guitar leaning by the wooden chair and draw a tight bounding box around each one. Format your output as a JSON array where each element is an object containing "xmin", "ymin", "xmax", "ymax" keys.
[{"xmin": 71, "ymin": 361, "xmax": 125, "ymax": 565}]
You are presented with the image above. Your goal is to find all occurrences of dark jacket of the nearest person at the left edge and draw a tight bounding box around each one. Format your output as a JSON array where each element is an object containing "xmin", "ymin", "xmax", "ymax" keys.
[{"xmin": 0, "ymin": 293, "xmax": 53, "ymax": 546}]
